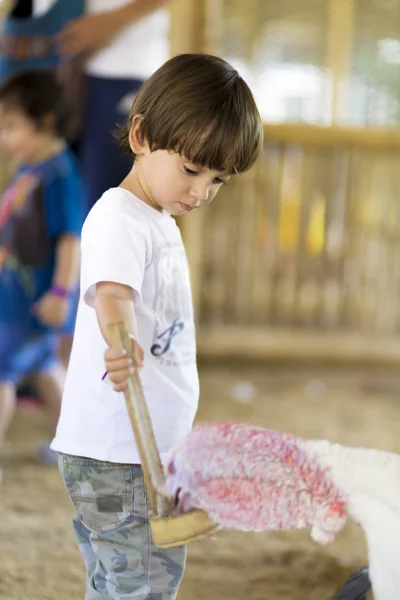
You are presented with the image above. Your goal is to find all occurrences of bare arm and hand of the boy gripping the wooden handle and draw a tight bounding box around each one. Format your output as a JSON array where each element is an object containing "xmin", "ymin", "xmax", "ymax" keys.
[{"xmin": 94, "ymin": 281, "xmax": 143, "ymax": 391}]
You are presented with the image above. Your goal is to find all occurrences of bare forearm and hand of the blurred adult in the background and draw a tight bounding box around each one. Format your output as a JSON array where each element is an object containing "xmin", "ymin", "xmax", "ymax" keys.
[{"xmin": 57, "ymin": 0, "xmax": 168, "ymax": 59}]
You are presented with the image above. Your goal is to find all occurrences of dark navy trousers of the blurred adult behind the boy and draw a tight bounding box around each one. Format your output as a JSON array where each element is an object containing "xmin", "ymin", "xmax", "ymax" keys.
[{"xmin": 76, "ymin": 76, "xmax": 143, "ymax": 210}]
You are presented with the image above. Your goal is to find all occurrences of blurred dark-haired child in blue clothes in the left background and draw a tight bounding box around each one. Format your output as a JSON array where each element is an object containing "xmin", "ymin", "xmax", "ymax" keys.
[{"xmin": 0, "ymin": 71, "xmax": 85, "ymax": 462}]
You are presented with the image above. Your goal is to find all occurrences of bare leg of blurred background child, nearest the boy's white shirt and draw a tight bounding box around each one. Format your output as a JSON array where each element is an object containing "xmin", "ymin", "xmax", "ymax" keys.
[{"xmin": 32, "ymin": 365, "xmax": 65, "ymax": 435}]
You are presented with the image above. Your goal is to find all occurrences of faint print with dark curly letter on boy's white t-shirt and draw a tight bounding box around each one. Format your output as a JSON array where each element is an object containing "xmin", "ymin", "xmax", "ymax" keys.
[{"xmin": 151, "ymin": 244, "xmax": 196, "ymax": 366}]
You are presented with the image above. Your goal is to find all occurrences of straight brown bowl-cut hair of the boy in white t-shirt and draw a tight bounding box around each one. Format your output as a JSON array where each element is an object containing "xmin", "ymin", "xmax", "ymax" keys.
[{"xmin": 116, "ymin": 54, "xmax": 263, "ymax": 173}]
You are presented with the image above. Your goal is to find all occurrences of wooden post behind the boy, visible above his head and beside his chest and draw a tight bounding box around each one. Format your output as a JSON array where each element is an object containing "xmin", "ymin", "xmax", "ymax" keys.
[{"xmin": 170, "ymin": 0, "xmax": 207, "ymax": 315}]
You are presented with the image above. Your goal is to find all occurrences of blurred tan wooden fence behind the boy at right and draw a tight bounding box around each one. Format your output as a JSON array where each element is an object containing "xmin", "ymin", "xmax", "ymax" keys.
[{"xmin": 183, "ymin": 125, "xmax": 400, "ymax": 362}]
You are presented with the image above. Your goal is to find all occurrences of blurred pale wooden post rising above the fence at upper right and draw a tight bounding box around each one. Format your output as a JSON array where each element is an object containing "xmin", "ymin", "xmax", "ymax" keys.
[{"xmin": 326, "ymin": 0, "xmax": 354, "ymax": 125}]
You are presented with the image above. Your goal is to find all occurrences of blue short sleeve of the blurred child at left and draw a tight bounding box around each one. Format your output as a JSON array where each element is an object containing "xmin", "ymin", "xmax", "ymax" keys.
[{"xmin": 44, "ymin": 156, "xmax": 86, "ymax": 238}]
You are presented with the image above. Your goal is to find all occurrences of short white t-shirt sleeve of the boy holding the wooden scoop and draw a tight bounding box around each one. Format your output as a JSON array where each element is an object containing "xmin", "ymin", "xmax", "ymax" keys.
[{"xmin": 81, "ymin": 198, "xmax": 149, "ymax": 307}]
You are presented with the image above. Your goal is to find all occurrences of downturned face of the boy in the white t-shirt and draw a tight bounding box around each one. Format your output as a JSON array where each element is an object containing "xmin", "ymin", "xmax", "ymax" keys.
[{"xmin": 135, "ymin": 150, "xmax": 230, "ymax": 216}]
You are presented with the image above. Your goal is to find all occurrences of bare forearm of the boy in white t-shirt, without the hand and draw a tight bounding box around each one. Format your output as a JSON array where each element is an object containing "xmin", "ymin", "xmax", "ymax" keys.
[{"xmin": 94, "ymin": 291, "xmax": 137, "ymax": 346}]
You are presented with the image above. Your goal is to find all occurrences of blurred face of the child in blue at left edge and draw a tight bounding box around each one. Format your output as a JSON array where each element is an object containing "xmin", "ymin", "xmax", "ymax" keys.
[{"xmin": 0, "ymin": 104, "xmax": 47, "ymax": 163}]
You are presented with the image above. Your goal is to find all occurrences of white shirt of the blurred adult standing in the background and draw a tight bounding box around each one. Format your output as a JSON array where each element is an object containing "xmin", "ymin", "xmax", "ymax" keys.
[{"xmin": 33, "ymin": 0, "xmax": 169, "ymax": 79}]
